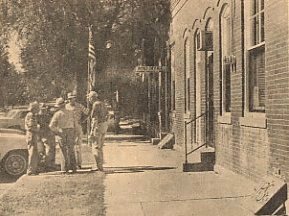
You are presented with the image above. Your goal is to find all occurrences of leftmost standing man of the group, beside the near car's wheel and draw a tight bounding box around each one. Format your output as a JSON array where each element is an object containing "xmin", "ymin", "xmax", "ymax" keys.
[{"xmin": 25, "ymin": 101, "xmax": 40, "ymax": 175}]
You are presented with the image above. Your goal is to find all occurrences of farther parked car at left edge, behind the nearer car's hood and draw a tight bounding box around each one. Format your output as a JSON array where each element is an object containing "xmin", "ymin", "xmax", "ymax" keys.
[{"xmin": 0, "ymin": 108, "xmax": 28, "ymax": 130}]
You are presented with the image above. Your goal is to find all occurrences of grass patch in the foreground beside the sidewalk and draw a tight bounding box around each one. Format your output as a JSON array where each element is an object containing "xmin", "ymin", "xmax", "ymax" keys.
[{"xmin": 0, "ymin": 172, "xmax": 105, "ymax": 216}]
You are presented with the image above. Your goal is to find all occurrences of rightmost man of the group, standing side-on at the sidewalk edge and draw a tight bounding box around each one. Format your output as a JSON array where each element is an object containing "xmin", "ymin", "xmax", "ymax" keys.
[{"xmin": 87, "ymin": 91, "xmax": 108, "ymax": 171}]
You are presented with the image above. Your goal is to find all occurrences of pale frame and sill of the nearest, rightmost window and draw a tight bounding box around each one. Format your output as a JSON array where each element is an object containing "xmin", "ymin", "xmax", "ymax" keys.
[{"xmin": 240, "ymin": 0, "xmax": 267, "ymax": 128}]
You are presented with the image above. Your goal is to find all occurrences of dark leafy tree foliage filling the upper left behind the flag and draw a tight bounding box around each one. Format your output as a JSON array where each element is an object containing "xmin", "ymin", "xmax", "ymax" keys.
[{"xmin": 0, "ymin": 0, "xmax": 170, "ymax": 106}]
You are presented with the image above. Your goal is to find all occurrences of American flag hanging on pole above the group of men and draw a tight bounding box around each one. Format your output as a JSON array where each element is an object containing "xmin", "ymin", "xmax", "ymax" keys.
[{"xmin": 88, "ymin": 26, "xmax": 96, "ymax": 92}]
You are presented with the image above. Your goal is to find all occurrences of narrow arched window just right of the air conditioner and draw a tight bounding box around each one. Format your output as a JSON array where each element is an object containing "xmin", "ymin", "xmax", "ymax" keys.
[{"xmin": 220, "ymin": 5, "xmax": 232, "ymax": 114}]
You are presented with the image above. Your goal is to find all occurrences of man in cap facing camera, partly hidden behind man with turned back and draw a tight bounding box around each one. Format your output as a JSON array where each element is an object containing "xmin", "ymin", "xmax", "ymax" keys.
[{"xmin": 65, "ymin": 93, "xmax": 89, "ymax": 168}]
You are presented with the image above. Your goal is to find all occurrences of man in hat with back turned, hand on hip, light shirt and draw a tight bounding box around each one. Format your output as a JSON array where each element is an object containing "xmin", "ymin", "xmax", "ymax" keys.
[{"xmin": 49, "ymin": 98, "xmax": 76, "ymax": 172}]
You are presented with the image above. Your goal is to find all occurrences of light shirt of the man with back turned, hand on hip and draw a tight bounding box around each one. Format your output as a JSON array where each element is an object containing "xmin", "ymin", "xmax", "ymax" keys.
[{"xmin": 49, "ymin": 109, "xmax": 75, "ymax": 132}]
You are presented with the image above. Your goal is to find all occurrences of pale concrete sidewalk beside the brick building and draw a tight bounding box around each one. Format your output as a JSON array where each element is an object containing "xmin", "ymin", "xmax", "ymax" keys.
[{"xmin": 99, "ymin": 141, "xmax": 254, "ymax": 216}]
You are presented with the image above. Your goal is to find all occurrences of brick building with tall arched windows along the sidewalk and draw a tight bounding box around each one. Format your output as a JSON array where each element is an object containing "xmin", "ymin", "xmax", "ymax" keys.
[{"xmin": 170, "ymin": 0, "xmax": 289, "ymax": 180}]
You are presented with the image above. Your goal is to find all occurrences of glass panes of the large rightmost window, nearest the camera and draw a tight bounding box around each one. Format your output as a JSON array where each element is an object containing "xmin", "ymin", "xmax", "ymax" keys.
[{"xmin": 247, "ymin": 0, "xmax": 266, "ymax": 112}]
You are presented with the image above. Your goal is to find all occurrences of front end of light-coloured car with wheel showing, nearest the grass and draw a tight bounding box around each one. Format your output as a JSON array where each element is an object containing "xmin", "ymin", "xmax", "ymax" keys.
[{"xmin": 0, "ymin": 128, "xmax": 28, "ymax": 177}]
